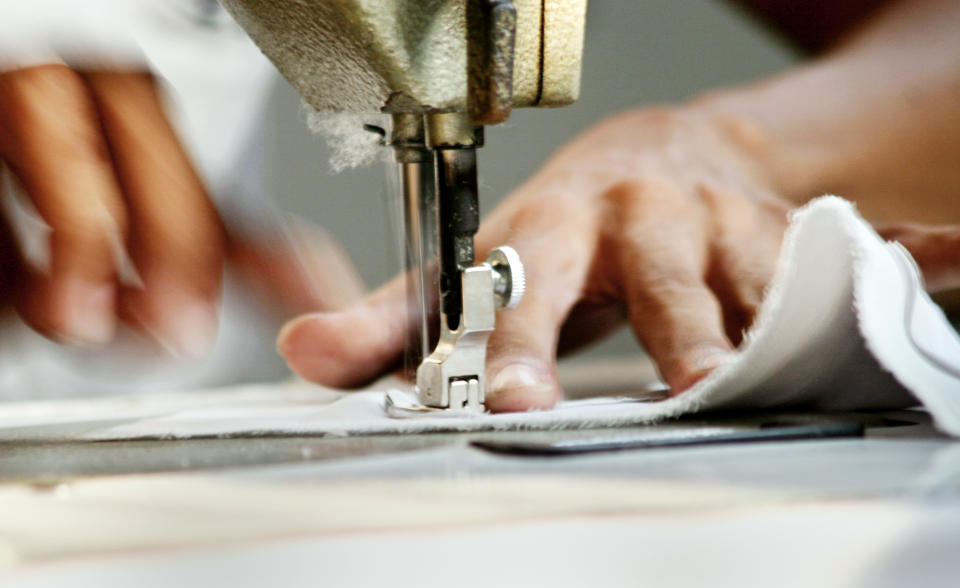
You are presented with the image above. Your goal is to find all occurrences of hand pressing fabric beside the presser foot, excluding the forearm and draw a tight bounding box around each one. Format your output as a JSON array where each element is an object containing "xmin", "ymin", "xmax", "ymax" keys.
[{"xmin": 279, "ymin": 109, "xmax": 790, "ymax": 410}]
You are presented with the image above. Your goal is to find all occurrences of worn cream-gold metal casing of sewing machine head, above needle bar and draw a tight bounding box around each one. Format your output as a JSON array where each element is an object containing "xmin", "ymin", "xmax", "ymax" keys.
[{"xmin": 223, "ymin": 0, "xmax": 586, "ymax": 122}]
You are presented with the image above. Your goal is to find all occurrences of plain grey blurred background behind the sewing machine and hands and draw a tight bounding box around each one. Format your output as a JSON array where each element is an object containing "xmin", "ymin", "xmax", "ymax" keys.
[{"xmin": 263, "ymin": 0, "xmax": 801, "ymax": 356}]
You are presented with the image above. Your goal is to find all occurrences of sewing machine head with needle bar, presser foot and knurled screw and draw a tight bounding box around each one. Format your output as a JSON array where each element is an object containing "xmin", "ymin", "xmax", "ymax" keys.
[{"xmin": 223, "ymin": 0, "xmax": 586, "ymax": 410}]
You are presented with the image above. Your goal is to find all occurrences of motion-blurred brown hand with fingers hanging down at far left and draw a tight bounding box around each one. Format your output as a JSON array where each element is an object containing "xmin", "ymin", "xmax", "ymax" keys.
[{"xmin": 0, "ymin": 65, "xmax": 224, "ymax": 356}]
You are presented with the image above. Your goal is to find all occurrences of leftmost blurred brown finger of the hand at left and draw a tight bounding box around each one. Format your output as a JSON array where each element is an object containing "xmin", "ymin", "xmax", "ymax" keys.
[{"xmin": 0, "ymin": 65, "xmax": 126, "ymax": 344}]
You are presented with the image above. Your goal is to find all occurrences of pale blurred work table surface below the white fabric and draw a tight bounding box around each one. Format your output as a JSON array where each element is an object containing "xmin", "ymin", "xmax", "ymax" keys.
[{"xmin": 0, "ymin": 384, "xmax": 960, "ymax": 586}]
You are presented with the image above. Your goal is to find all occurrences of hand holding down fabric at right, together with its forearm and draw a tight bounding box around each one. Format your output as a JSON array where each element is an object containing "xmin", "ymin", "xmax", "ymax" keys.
[{"xmin": 279, "ymin": 0, "xmax": 960, "ymax": 410}]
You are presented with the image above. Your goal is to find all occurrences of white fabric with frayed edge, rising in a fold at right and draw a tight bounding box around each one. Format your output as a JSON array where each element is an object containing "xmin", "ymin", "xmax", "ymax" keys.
[{"xmin": 0, "ymin": 196, "xmax": 960, "ymax": 439}]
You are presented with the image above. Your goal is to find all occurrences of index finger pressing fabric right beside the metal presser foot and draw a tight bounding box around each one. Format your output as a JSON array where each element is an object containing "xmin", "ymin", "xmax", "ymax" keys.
[{"xmin": 478, "ymin": 196, "xmax": 596, "ymax": 412}]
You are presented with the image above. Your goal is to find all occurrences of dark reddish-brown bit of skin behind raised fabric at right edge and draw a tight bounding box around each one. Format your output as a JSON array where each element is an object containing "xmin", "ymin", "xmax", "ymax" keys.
[{"xmin": 877, "ymin": 224, "xmax": 960, "ymax": 292}]
